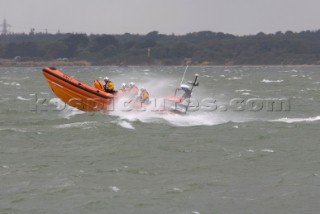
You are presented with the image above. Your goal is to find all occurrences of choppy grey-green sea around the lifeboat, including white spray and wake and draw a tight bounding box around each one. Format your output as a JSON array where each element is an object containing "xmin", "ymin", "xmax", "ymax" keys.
[{"xmin": 0, "ymin": 67, "xmax": 320, "ymax": 214}]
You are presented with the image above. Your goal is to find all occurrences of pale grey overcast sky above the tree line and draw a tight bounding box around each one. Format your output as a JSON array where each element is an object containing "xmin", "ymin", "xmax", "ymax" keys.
[{"xmin": 0, "ymin": 0, "xmax": 320, "ymax": 35}]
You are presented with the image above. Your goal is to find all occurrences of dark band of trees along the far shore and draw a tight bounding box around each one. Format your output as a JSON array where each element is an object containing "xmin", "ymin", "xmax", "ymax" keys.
[{"xmin": 0, "ymin": 30, "xmax": 320, "ymax": 65}]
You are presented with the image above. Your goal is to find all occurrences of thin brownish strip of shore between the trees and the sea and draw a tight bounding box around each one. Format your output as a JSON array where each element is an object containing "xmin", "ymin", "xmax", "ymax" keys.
[{"xmin": 0, "ymin": 59, "xmax": 320, "ymax": 67}]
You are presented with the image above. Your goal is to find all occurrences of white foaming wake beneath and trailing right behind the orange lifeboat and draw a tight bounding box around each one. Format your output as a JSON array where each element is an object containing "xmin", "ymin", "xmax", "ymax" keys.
[{"xmin": 50, "ymin": 98, "xmax": 320, "ymax": 130}]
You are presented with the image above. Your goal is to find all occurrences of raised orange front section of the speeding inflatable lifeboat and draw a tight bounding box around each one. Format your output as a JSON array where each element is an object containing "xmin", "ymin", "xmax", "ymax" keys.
[{"xmin": 42, "ymin": 67, "xmax": 115, "ymax": 112}]
